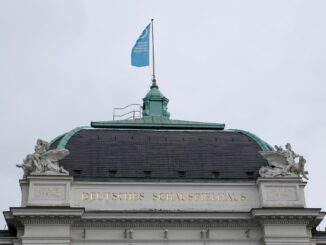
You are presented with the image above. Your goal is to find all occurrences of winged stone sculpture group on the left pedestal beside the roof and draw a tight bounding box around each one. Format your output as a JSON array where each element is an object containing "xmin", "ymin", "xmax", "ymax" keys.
[{"xmin": 16, "ymin": 139, "xmax": 69, "ymax": 179}]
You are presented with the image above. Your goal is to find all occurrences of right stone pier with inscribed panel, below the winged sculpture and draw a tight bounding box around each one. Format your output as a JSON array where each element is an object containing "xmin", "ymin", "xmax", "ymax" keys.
[{"xmin": 251, "ymin": 178, "xmax": 324, "ymax": 245}]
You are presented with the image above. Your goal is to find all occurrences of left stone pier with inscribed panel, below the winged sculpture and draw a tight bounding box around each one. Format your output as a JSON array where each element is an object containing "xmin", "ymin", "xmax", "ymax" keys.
[{"xmin": 10, "ymin": 175, "xmax": 84, "ymax": 245}]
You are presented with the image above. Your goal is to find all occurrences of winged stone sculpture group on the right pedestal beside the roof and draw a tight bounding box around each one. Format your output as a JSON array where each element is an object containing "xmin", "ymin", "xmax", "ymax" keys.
[{"xmin": 259, "ymin": 143, "xmax": 308, "ymax": 180}]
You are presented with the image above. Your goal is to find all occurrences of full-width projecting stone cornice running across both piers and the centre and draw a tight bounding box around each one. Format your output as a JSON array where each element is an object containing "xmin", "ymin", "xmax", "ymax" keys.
[{"xmin": 5, "ymin": 207, "xmax": 325, "ymax": 228}]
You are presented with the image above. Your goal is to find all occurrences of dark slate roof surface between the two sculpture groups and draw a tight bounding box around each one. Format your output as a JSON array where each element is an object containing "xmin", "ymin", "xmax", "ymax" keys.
[{"xmin": 55, "ymin": 128, "xmax": 267, "ymax": 179}]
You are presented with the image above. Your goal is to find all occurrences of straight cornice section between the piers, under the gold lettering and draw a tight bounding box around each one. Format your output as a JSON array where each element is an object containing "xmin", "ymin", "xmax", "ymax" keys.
[{"xmin": 73, "ymin": 212, "xmax": 258, "ymax": 228}]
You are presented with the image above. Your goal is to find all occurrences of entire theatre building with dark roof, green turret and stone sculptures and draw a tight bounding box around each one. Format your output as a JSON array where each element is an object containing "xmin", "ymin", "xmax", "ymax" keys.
[{"xmin": 0, "ymin": 80, "xmax": 326, "ymax": 245}]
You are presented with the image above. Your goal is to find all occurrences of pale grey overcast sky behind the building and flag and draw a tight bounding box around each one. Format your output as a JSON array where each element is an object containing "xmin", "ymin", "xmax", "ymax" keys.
[{"xmin": 0, "ymin": 0, "xmax": 326, "ymax": 229}]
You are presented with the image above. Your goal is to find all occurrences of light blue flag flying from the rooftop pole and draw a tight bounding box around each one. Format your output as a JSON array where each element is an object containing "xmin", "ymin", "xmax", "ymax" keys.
[{"xmin": 131, "ymin": 24, "xmax": 151, "ymax": 67}]
